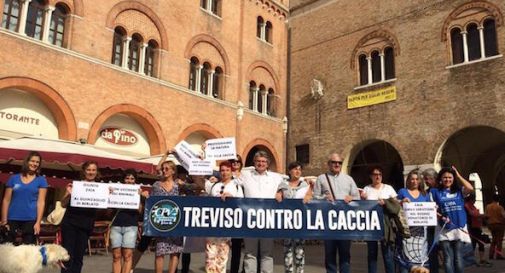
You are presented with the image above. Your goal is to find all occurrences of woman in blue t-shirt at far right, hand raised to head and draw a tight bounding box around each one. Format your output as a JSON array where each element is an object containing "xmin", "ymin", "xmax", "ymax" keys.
[{"xmin": 430, "ymin": 166, "xmax": 473, "ymax": 273}]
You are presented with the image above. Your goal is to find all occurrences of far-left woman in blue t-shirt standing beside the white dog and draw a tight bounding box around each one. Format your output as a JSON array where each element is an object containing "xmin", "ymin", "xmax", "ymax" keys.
[{"xmin": 0, "ymin": 152, "xmax": 47, "ymax": 244}]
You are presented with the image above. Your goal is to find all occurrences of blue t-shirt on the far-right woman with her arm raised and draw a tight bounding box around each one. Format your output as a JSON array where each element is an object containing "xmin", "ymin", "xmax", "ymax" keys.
[{"xmin": 430, "ymin": 189, "xmax": 466, "ymax": 230}]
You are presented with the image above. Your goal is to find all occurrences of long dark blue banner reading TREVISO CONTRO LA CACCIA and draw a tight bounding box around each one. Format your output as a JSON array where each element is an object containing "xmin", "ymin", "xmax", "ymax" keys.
[{"xmin": 144, "ymin": 196, "xmax": 384, "ymax": 240}]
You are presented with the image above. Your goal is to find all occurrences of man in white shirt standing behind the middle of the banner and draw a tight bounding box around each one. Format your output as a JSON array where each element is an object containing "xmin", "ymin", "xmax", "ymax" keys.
[{"xmin": 238, "ymin": 151, "xmax": 282, "ymax": 273}]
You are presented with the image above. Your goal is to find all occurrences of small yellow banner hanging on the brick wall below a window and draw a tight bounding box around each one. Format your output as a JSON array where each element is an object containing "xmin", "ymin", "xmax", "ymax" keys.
[{"xmin": 347, "ymin": 86, "xmax": 396, "ymax": 109}]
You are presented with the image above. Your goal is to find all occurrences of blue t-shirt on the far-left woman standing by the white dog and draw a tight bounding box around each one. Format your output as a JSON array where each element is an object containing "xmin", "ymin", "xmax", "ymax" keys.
[{"xmin": 7, "ymin": 174, "xmax": 47, "ymax": 221}]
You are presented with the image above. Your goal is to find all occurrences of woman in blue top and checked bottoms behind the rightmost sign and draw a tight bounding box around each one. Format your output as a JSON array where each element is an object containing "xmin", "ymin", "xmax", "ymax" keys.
[{"xmin": 397, "ymin": 169, "xmax": 430, "ymax": 273}]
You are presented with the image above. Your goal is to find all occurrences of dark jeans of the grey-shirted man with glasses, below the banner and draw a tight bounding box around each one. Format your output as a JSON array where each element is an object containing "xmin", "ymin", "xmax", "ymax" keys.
[{"xmin": 324, "ymin": 240, "xmax": 351, "ymax": 273}]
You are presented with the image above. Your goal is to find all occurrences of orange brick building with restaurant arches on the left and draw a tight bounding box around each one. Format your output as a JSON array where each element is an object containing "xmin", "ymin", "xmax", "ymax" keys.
[{"xmin": 0, "ymin": 0, "xmax": 289, "ymax": 174}]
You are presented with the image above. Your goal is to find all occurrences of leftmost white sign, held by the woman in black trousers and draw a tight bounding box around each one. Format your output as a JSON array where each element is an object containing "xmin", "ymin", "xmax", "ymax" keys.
[{"xmin": 70, "ymin": 181, "xmax": 109, "ymax": 209}]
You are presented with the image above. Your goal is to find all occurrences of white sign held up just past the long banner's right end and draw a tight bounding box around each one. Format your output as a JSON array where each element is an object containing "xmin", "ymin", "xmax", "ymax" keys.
[{"xmin": 403, "ymin": 202, "xmax": 437, "ymax": 227}]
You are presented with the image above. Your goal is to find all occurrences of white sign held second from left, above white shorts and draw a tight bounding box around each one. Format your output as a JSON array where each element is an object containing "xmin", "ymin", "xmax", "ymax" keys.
[{"xmin": 108, "ymin": 183, "xmax": 140, "ymax": 209}]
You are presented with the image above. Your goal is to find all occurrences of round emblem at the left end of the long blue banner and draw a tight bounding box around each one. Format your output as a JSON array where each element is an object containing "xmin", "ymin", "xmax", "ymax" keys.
[{"xmin": 149, "ymin": 200, "xmax": 181, "ymax": 232}]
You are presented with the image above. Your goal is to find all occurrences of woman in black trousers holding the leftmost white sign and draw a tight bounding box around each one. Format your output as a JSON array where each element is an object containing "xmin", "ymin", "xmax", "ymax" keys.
[{"xmin": 61, "ymin": 161, "xmax": 99, "ymax": 273}]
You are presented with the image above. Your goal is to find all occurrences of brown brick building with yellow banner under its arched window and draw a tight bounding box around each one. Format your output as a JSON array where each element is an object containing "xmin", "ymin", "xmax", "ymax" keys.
[{"xmin": 287, "ymin": 0, "xmax": 505, "ymax": 200}]
